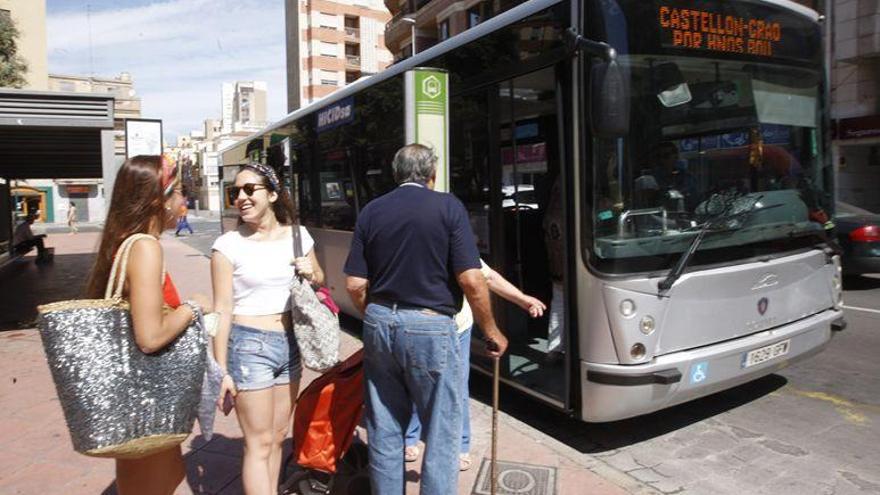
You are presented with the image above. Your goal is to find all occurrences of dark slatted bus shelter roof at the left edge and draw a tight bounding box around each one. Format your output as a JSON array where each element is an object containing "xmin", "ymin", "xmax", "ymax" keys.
[{"xmin": 0, "ymin": 89, "xmax": 113, "ymax": 179}]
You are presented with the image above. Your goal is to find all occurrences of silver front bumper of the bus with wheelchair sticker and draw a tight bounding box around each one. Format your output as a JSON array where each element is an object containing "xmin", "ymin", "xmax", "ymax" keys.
[{"xmin": 581, "ymin": 309, "xmax": 843, "ymax": 422}]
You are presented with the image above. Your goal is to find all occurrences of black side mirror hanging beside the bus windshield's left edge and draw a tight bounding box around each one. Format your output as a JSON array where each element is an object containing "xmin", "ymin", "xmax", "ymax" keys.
[{"xmin": 590, "ymin": 59, "xmax": 629, "ymax": 138}]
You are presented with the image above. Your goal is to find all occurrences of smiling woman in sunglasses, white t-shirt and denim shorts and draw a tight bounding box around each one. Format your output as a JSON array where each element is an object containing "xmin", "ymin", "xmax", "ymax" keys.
[{"xmin": 211, "ymin": 163, "xmax": 324, "ymax": 494}]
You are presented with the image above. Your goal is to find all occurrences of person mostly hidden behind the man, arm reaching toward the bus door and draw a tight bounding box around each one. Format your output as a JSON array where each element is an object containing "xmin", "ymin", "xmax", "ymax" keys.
[{"xmin": 403, "ymin": 259, "xmax": 547, "ymax": 471}]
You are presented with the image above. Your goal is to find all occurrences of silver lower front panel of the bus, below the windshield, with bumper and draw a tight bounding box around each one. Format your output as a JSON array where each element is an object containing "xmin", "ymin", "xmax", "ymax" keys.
[{"xmin": 577, "ymin": 250, "xmax": 842, "ymax": 422}]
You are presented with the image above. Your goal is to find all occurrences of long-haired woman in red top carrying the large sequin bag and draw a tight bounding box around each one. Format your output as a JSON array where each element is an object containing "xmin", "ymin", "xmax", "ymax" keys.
[{"xmin": 86, "ymin": 155, "xmax": 211, "ymax": 495}]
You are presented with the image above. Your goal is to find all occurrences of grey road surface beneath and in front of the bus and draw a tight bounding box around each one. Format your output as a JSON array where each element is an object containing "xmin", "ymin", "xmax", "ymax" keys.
[{"xmin": 181, "ymin": 226, "xmax": 880, "ymax": 495}]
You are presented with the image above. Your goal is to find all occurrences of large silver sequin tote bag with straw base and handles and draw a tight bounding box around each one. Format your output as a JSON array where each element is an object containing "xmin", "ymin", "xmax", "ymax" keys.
[{"xmin": 37, "ymin": 234, "xmax": 207, "ymax": 458}]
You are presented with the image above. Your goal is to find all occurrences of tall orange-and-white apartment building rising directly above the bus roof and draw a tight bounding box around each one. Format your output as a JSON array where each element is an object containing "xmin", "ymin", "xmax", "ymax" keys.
[{"xmin": 285, "ymin": 0, "xmax": 392, "ymax": 112}]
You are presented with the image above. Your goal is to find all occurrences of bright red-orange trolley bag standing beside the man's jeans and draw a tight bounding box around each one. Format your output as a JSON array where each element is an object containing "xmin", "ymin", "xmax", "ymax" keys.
[{"xmin": 293, "ymin": 349, "xmax": 364, "ymax": 474}]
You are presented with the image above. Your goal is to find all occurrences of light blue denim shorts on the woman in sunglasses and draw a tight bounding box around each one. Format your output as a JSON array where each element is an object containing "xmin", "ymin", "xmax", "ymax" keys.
[{"xmin": 229, "ymin": 324, "xmax": 302, "ymax": 390}]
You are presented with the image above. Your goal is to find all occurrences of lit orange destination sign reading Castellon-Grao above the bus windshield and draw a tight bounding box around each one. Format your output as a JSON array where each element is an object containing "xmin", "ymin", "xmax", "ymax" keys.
[{"xmin": 657, "ymin": 2, "xmax": 783, "ymax": 57}]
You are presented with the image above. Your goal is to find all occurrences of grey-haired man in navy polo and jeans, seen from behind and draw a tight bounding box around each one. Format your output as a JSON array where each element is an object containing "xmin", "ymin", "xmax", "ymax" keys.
[{"xmin": 345, "ymin": 144, "xmax": 507, "ymax": 495}]
